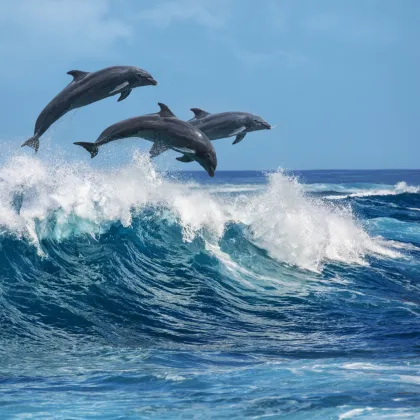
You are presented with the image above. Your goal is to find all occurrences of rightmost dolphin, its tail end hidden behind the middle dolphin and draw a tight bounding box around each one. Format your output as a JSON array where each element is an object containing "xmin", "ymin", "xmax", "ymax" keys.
[{"xmin": 188, "ymin": 108, "xmax": 271, "ymax": 144}]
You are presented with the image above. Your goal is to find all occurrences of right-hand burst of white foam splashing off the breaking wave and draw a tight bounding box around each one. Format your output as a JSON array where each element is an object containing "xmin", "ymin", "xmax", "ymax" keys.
[{"xmin": 235, "ymin": 172, "xmax": 399, "ymax": 271}]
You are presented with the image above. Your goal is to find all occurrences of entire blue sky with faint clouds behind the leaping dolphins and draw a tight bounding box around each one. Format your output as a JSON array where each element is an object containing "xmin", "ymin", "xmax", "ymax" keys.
[{"xmin": 0, "ymin": 0, "xmax": 420, "ymax": 170}]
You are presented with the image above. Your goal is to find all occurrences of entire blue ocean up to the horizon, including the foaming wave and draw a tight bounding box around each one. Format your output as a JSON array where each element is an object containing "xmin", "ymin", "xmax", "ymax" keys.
[{"xmin": 0, "ymin": 155, "xmax": 420, "ymax": 420}]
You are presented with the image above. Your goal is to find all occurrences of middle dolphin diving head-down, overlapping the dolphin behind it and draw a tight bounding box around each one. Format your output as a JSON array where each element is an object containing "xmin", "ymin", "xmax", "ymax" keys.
[{"xmin": 74, "ymin": 103, "xmax": 217, "ymax": 177}]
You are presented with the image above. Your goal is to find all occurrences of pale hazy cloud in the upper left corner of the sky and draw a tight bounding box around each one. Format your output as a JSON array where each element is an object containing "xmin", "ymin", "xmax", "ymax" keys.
[{"xmin": 0, "ymin": 0, "xmax": 131, "ymax": 58}]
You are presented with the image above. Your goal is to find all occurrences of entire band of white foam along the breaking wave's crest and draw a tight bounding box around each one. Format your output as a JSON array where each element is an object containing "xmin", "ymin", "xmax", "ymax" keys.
[{"xmin": 0, "ymin": 154, "xmax": 400, "ymax": 271}]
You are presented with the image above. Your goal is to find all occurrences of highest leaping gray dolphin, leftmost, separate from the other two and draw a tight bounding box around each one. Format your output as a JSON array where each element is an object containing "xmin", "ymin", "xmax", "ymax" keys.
[{"xmin": 22, "ymin": 66, "xmax": 157, "ymax": 152}]
